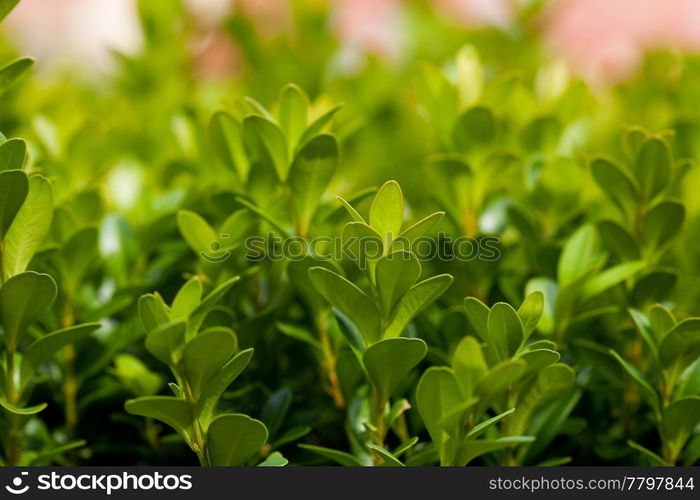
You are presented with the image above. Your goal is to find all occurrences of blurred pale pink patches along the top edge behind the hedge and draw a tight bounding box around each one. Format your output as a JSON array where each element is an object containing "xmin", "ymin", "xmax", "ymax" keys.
[{"xmin": 5, "ymin": 0, "xmax": 700, "ymax": 86}]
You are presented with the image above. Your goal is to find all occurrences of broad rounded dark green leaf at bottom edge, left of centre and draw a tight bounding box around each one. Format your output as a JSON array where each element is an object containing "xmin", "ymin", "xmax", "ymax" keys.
[{"xmin": 207, "ymin": 413, "xmax": 267, "ymax": 467}]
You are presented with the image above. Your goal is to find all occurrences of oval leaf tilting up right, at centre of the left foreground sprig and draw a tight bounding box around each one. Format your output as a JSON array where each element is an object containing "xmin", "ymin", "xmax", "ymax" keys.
[{"xmin": 183, "ymin": 329, "xmax": 236, "ymax": 399}]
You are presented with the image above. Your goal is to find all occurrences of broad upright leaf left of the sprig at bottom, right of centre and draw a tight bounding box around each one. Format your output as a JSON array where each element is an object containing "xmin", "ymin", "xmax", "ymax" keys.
[{"xmin": 416, "ymin": 366, "xmax": 464, "ymax": 464}]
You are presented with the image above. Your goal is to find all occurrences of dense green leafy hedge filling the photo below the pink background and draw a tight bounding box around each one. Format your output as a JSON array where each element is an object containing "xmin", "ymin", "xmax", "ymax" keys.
[{"xmin": 0, "ymin": 2, "xmax": 700, "ymax": 466}]
